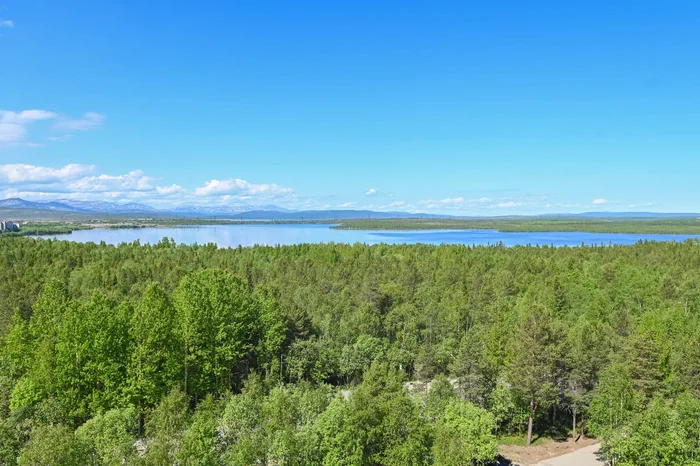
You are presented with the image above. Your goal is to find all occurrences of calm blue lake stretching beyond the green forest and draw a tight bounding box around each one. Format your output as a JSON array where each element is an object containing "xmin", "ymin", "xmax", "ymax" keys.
[{"xmin": 37, "ymin": 225, "xmax": 700, "ymax": 247}]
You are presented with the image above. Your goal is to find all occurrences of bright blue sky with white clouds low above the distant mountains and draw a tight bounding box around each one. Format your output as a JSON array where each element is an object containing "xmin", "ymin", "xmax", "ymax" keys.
[{"xmin": 0, "ymin": 0, "xmax": 700, "ymax": 216}]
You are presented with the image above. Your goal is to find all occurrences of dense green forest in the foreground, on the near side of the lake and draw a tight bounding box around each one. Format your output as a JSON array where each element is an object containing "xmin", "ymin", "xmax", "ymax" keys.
[{"xmin": 0, "ymin": 237, "xmax": 700, "ymax": 466}]
